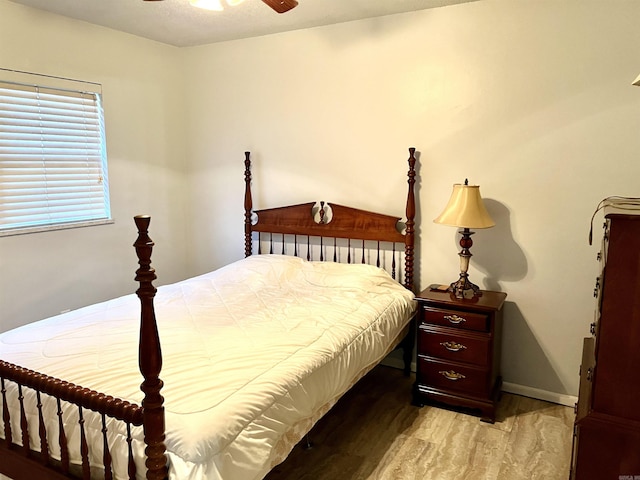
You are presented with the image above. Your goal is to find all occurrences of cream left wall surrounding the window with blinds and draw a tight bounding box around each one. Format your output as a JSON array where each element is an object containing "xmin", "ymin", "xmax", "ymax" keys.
[{"xmin": 0, "ymin": 0, "xmax": 188, "ymax": 331}]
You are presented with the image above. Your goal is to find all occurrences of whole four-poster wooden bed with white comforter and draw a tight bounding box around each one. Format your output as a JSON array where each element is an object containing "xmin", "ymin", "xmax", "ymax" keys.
[{"xmin": 0, "ymin": 148, "xmax": 416, "ymax": 480}]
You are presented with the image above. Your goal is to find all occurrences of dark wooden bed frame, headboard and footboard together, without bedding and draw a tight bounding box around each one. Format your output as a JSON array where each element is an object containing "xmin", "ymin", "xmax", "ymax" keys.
[{"xmin": 0, "ymin": 148, "xmax": 416, "ymax": 480}]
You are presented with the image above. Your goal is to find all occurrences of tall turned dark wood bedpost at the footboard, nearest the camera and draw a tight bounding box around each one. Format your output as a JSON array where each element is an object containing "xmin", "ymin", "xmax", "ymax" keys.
[{"xmin": 133, "ymin": 215, "xmax": 168, "ymax": 480}]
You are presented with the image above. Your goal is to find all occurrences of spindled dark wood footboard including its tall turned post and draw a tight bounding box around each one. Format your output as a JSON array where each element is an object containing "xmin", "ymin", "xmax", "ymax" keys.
[{"xmin": 0, "ymin": 216, "xmax": 168, "ymax": 480}]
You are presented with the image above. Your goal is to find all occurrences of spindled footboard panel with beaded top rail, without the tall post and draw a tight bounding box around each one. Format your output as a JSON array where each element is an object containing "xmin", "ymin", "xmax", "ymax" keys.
[{"xmin": 0, "ymin": 360, "xmax": 143, "ymax": 480}]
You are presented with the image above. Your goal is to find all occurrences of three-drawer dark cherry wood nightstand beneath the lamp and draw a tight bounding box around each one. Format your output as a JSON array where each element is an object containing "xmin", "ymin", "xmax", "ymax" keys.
[{"xmin": 413, "ymin": 288, "xmax": 507, "ymax": 423}]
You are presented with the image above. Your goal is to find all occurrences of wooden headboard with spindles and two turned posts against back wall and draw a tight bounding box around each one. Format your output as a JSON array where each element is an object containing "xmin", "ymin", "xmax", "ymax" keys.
[{"xmin": 244, "ymin": 147, "xmax": 416, "ymax": 291}]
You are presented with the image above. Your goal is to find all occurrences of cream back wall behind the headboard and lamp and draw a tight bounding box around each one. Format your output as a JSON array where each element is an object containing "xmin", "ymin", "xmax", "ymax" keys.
[{"xmin": 180, "ymin": 0, "xmax": 640, "ymax": 403}]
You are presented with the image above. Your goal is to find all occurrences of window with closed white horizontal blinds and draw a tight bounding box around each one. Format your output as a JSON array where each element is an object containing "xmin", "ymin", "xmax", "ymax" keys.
[{"xmin": 0, "ymin": 71, "xmax": 111, "ymax": 236}]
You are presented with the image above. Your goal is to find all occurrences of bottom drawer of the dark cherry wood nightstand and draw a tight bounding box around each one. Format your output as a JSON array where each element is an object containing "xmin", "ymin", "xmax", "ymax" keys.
[{"xmin": 418, "ymin": 357, "xmax": 489, "ymax": 397}]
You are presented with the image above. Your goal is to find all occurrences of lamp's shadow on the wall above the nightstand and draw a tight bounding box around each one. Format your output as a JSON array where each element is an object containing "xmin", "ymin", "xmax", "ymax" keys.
[{"xmin": 471, "ymin": 198, "xmax": 528, "ymax": 291}]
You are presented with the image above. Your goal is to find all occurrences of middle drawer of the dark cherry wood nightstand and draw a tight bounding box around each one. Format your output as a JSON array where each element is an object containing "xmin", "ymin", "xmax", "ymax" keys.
[{"xmin": 418, "ymin": 324, "xmax": 491, "ymax": 367}]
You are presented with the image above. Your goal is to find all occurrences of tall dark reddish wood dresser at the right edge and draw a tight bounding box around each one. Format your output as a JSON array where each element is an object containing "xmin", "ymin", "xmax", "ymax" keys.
[{"xmin": 571, "ymin": 214, "xmax": 640, "ymax": 480}]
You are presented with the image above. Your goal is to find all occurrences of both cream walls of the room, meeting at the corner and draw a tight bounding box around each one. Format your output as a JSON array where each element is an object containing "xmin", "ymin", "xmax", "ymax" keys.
[{"xmin": 0, "ymin": 0, "xmax": 640, "ymax": 401}]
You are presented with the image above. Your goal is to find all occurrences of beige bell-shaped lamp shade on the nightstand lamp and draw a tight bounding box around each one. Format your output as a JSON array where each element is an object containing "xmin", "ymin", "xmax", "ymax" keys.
[{"xmin": 434, "ymin": 183, "xmax": 496, "ymax": 228}]
